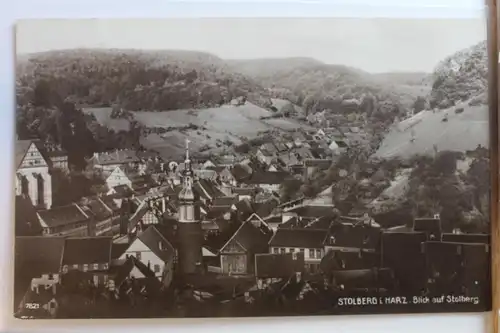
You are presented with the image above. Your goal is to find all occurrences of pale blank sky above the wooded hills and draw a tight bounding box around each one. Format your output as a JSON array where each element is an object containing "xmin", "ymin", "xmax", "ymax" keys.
[{"xmin": 16, "ymin": 18, "xmax": 486, "ymax": 73}]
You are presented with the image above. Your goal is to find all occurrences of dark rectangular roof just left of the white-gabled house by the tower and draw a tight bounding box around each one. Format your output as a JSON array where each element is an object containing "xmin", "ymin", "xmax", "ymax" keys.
[{"xmin": 63, "ymin": 237, "xmax": 112, "ymax": 265}]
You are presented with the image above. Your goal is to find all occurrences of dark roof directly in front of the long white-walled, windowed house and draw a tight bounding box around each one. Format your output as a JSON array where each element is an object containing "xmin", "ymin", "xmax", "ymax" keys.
[{"xmin": 255, "ymin": 253, "xmax": 305, "ymax": 279}]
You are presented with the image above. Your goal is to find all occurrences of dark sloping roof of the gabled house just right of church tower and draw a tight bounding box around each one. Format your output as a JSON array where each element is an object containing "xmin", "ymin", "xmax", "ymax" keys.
[{"xmin": 221, "ymin": 222, "xmax": 272, "ymax": 253}]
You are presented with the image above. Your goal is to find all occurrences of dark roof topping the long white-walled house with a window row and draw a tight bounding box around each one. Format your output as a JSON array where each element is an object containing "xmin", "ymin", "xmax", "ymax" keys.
[{"xmin": 269, "ymin": 228, "xmax": 327, "ymax": 248}]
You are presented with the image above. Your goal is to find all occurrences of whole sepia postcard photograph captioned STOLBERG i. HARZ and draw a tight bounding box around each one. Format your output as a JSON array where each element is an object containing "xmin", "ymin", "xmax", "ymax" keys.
[{"xmin": 11, "ymin": 18, "xmax": 491, "ymax": 319}]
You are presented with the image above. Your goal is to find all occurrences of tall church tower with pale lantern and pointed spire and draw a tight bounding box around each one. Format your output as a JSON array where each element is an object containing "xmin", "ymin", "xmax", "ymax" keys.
[{"xmin": 177, "ymin": 140, "xmax": 203, "ymax": 274}]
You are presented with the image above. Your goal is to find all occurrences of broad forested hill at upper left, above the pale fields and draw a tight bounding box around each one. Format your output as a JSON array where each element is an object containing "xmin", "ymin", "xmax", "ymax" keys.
[{"xmin": 17, "ymin": 50, "xmax": 272, "ymax": 111}]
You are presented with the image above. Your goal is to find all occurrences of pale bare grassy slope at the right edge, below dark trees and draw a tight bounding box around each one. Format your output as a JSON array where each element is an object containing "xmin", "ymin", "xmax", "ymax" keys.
[{"xmin": 375, "ymin": 103, "xmax": 489, "ymax": 158}]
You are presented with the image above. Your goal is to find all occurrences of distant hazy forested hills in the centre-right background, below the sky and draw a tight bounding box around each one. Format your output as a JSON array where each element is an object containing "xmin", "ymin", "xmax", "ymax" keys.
[{"xmin": 232, "ymin": 58, "xmax": 427, "ymax": 118}]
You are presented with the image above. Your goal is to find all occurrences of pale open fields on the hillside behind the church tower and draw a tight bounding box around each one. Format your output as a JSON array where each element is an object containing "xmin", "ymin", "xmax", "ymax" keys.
[{"xmin": 84, "ymin": 102, "xmax": 306, "ymax": 156}]
